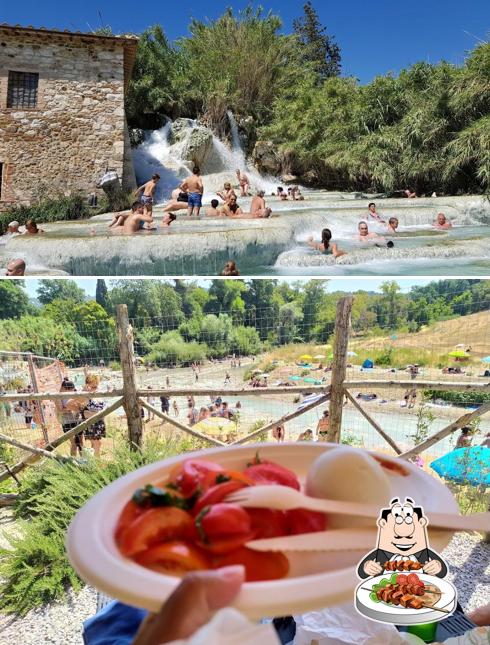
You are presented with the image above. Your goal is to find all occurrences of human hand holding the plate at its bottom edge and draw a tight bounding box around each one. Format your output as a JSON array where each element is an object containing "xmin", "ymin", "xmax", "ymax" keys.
[{"xmin": 132, "ymin": 565, "xmax": 245, "ymax": 645}]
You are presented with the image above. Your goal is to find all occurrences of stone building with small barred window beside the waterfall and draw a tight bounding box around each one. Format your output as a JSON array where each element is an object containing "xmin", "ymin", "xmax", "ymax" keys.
[{"xmin": 0, "ymin": 24, "xmax": 138, "ymax": 211}]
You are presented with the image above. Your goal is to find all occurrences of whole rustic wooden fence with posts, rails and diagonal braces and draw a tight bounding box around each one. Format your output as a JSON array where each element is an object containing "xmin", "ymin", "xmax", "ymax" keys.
[{"xmin": 0, "ymin": 296, "xmax": 490, "ymax": 482}]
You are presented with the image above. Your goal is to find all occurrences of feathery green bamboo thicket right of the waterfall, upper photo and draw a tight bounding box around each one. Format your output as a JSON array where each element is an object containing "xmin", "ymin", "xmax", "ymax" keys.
[{"xmin": 262, "ymin": 43, "xmax": 490, "ymax": 194}]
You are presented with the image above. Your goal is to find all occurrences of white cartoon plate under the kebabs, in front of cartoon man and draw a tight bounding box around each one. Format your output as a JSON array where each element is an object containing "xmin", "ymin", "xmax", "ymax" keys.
[{"xmin": 356, "ymin": 573, "xmax": 456, "ymax": 625}]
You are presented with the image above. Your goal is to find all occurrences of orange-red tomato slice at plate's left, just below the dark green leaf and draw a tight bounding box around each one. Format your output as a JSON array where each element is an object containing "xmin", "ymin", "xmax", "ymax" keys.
[{"xmin": 119, "ymin": 506, "xmax": 192, "ymax": 556}]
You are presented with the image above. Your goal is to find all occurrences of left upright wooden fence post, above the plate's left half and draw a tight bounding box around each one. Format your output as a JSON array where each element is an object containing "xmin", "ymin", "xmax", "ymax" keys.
[{"xmin": 116, "ymin": 305, "xmax": 143, "ymax": 450}]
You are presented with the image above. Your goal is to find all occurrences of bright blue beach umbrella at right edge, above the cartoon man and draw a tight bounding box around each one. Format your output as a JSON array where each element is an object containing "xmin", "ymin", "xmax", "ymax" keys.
[{"xmin": 430, "ymin": 446, "xmax": 490, "ymax": 486}]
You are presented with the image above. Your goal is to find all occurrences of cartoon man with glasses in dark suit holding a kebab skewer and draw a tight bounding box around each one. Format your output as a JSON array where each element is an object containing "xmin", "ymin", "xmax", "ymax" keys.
[{"xmin": 357, "ymin": 497, "xmax": 447, "ymax": 578}]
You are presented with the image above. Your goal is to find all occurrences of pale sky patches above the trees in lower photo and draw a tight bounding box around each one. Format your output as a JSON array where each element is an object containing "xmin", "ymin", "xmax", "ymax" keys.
[{"xmin": 25, "ymin": 277, "xmax": 438, "ymax": 298}]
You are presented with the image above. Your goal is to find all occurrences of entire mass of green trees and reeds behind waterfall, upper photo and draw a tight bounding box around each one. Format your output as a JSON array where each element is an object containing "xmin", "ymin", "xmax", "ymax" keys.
[{"xmin": 127, "ymin": 2, "xmax": 490, "ymax": 194}]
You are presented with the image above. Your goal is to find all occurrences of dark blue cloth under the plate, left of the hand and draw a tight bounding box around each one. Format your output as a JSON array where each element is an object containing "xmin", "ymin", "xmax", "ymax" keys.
[{"xmin": 83, "ymin": 600, "xmax": 148, "ymax": 645}]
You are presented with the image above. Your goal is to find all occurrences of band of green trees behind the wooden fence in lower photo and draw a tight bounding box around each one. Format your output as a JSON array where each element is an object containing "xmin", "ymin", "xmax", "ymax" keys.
[{"xmin": 0, "ymin": 280, "xmax": 490, "ymax": 366}]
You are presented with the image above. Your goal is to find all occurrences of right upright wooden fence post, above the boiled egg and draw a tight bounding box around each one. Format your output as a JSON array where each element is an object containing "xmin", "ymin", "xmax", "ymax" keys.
[{"xmin": 327, "ymin": 296, "xmax": 354, "ymax": 443}]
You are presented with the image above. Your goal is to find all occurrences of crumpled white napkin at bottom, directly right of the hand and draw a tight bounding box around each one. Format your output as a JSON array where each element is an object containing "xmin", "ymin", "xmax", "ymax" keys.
[{"xmin": 169, "ymin": 607, "xmax": 281, "ymax": 645}]
